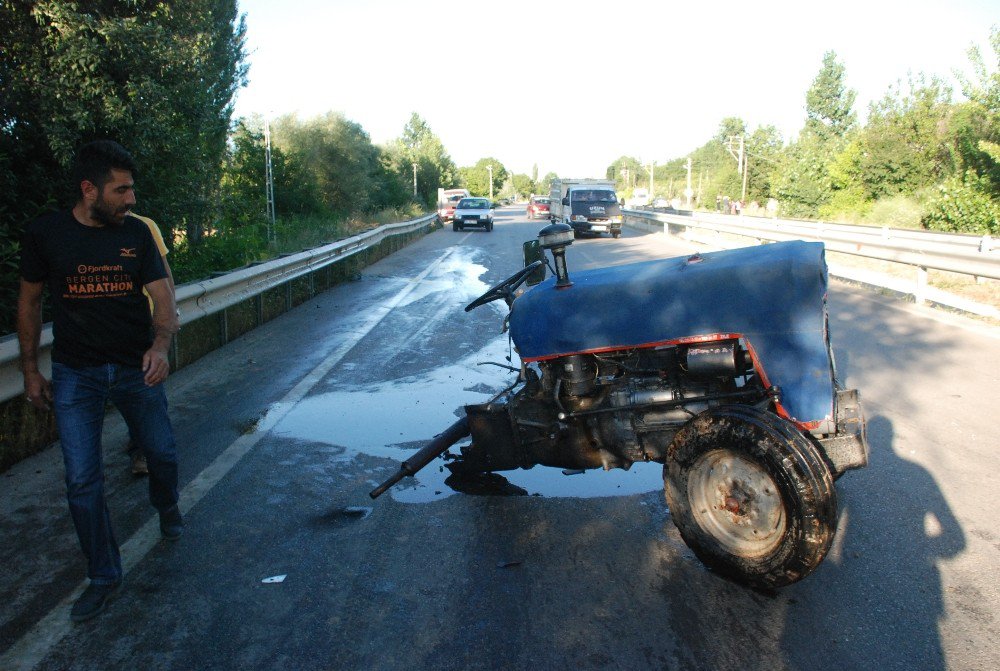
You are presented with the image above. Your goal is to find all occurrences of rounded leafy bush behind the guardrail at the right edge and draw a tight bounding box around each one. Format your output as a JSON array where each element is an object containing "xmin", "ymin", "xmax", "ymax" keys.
[{"xmin": 922, "ymin": 170, "xmax": 1000, "ymax": 235}]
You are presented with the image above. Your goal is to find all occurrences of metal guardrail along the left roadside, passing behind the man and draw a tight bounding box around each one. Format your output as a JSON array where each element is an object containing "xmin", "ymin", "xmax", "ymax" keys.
[{"xmin": 0, "ymin": 214, "xmax": 437, "ymax": 403}]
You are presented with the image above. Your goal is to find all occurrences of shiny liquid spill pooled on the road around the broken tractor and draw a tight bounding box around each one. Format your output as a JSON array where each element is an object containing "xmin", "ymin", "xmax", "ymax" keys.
[{"xmin": 259, "ymin": 250, "xmax": 663, "ymax": 503}]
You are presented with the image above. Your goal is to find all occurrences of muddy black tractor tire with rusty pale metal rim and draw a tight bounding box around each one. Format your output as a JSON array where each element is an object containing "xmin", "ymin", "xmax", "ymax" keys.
[{"xmin": 663, "ymin": 405, "xmax": 837, "ymax": 588}]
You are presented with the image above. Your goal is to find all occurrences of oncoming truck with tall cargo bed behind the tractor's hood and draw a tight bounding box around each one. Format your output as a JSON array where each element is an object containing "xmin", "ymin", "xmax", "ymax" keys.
[{"xmin": 549, "ymin": 179, "xmax": 622, "ymax": 238}]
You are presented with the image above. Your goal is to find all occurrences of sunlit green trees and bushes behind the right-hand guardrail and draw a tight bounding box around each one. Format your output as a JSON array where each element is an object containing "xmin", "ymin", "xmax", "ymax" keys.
[{"xmin": 607, "ymin": 35, "xmax": 1000, "ymax": 236}]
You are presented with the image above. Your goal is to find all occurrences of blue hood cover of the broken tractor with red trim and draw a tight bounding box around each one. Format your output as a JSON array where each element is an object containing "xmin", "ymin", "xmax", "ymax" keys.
[{"xmin": 510, "ymin": 241, "xmax": 835, "ymax": 427}]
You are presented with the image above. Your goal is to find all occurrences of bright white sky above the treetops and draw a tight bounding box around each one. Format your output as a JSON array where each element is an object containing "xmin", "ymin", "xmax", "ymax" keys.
[{"xmin": 236, "ymin": 0, "xmax": 1000, "ymax": 177}]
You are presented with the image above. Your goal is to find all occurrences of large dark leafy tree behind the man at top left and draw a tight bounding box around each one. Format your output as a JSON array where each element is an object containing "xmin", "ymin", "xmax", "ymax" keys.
[{"xmin": 0, "ymin": 0, "xmax": 246, "ymax": 329}]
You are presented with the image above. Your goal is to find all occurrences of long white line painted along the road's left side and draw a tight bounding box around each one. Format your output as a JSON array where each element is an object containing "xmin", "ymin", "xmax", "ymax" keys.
[{"xmin": 0, "ymin": 247, "xmax": 458, "ymax": 671}]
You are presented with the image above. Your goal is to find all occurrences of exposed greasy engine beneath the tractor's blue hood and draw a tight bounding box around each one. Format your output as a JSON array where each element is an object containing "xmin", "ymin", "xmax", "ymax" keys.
[{"xmin": 449, "ymin": 339, "xmax": 769, "ymax": 471}]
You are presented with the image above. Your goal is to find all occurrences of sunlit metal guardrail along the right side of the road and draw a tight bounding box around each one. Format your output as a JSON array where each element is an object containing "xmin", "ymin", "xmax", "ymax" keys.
[{"xmin": 625, "ymin": 210, "xmax": 1000, "ymax": 318}]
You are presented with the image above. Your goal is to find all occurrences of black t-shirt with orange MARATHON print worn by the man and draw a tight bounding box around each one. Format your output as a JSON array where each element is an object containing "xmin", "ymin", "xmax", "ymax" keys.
[{"xmin": 21, "ymin": 210, "xmax": 167, "ymax": 368}]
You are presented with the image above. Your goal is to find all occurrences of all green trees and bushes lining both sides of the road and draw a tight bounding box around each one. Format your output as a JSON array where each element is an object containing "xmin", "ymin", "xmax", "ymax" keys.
[{"xmin": 0, "ymin": 0, "xmax": 1000, "ymax": 333}]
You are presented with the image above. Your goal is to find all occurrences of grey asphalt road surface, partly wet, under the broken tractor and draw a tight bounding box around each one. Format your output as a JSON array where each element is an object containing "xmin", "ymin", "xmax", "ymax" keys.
[{"xmin": 0, "ymin": 208, "xmax": 1000, "ymax": 671}]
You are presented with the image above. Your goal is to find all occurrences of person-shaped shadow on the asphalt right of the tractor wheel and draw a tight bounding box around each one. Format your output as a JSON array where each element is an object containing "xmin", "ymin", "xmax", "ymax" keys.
[{"xmin": 783, "ymin": 416, "xmax": 965, "ymax": 670}]
